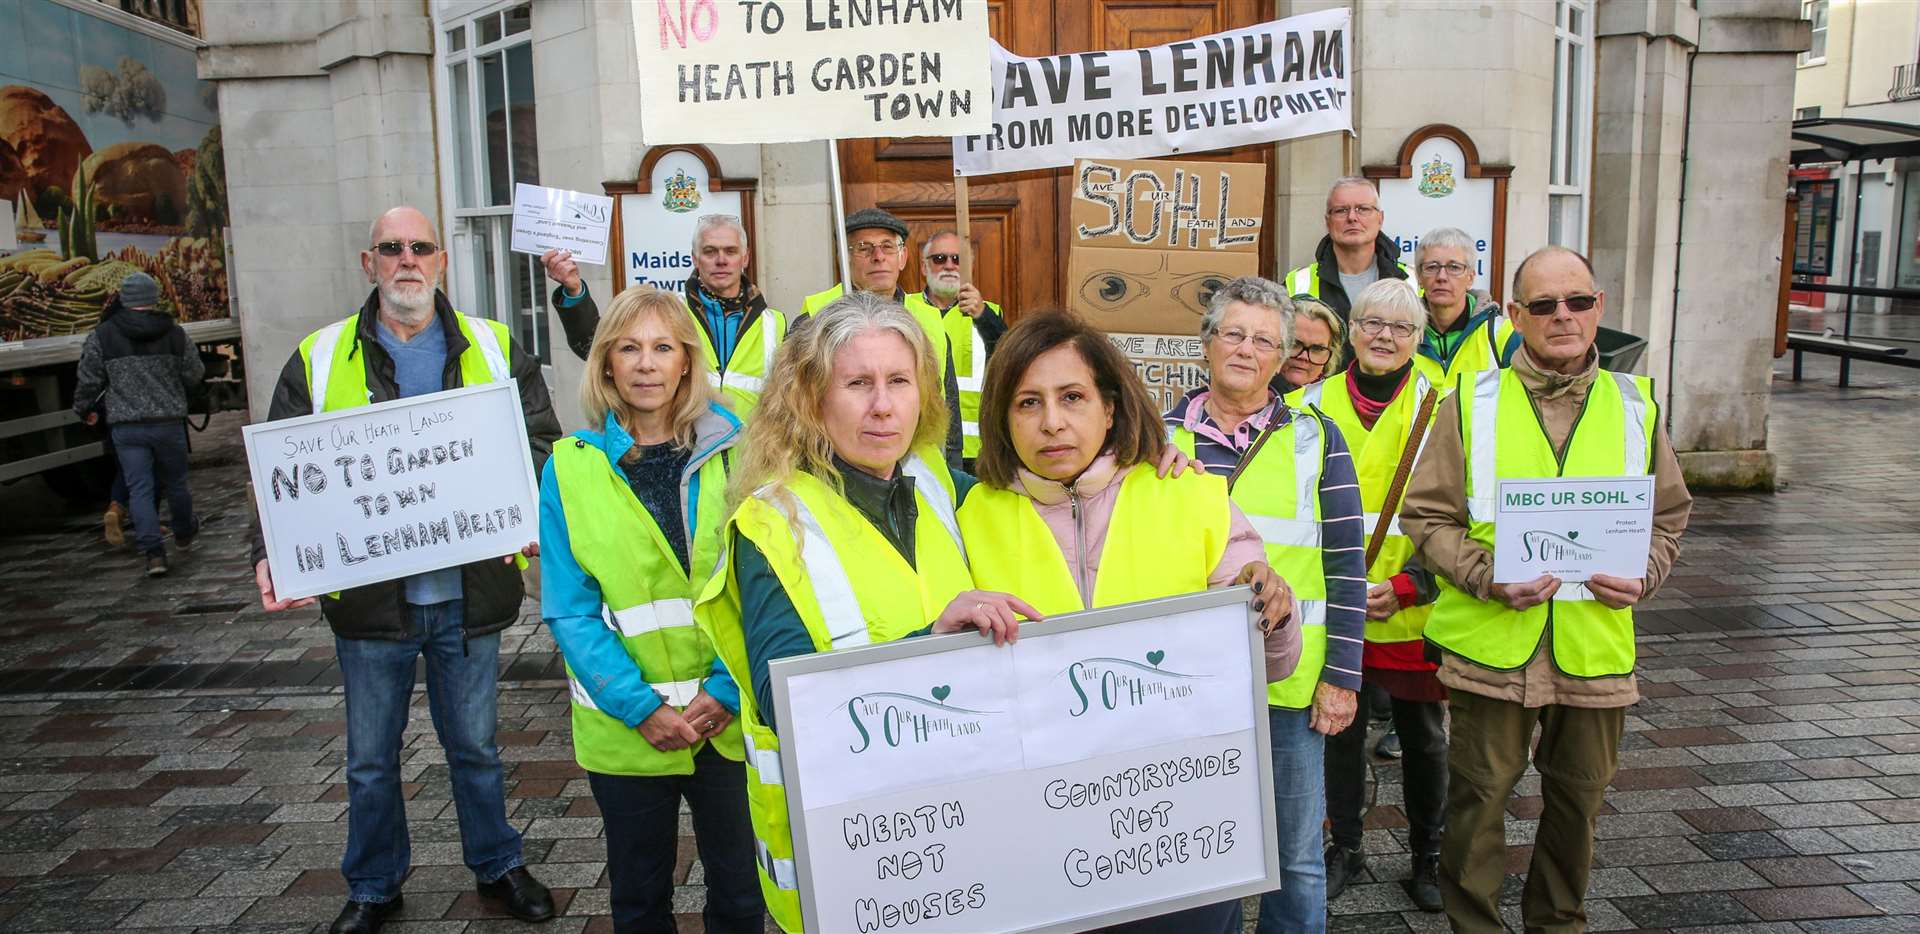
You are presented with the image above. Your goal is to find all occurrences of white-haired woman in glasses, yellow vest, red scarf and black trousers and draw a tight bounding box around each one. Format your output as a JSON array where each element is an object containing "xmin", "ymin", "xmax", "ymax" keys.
[{"xmin": 1286, "ymin": 278, "xmax": 1446, "ymax": 911}]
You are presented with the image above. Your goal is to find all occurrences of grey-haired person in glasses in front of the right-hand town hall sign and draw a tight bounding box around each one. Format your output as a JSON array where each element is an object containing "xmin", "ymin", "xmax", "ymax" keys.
[{"xmin": 1413, "ymin": 227, "xmax": 1521, "ymax": 382}]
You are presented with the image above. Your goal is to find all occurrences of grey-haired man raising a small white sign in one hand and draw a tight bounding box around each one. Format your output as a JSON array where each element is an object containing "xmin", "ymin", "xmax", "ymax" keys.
[{"xmin": 540, "ymin": 213, "xmax": 804, "ymax": 417}]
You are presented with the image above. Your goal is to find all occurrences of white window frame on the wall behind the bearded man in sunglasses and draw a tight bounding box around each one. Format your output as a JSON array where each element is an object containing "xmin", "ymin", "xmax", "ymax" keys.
[{"xmin": 432, "ymin": 0, "xmax": 553, "ymax": 365}]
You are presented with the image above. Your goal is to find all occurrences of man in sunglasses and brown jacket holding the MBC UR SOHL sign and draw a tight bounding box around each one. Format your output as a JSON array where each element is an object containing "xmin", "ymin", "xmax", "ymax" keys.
[{"xmin": 1400, "ymin": 246, "xmax": 1693, "ymax": 932}]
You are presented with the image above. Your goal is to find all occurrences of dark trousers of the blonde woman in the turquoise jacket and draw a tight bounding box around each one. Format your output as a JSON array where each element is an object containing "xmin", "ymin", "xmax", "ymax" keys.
[{"xmin": 588, "ymin": 749, "xmax": 766, "ymax": 934}]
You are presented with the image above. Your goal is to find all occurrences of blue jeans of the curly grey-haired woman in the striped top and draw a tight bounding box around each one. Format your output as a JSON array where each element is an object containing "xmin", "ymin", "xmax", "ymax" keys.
[{"xmin": 1254, "ymin": 707, "xmax": 1327, "ymax": 934}]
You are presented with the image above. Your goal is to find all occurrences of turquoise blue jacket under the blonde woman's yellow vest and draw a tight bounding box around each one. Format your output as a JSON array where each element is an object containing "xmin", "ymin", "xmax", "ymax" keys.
[{"xmin": 540, "ymin": 404, "xmax": 741, "ymax": 726}]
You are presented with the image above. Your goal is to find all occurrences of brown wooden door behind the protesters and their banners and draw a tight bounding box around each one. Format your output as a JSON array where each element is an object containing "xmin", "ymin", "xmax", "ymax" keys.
[{"xmin": 841, "ymin": 0, "xmax": 1273, "ymax": 317}]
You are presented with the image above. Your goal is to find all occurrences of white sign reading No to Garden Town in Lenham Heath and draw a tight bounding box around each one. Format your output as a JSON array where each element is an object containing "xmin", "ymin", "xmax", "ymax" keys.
[{"xmin": 240, "ymin": 381, "xmax": 540, "ymax": 598}]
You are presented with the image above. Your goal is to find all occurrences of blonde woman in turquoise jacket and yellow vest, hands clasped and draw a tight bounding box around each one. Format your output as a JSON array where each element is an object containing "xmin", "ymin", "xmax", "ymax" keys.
[{"xmin": 540, "ymin": 286, "xmax": 764, "ymax": 934}]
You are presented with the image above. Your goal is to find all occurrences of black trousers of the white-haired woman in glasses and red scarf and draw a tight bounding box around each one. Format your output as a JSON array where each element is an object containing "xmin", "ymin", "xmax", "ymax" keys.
[{"xmin": 1327, "ymin": 690, "xmax": 1446, "ymax": 853}]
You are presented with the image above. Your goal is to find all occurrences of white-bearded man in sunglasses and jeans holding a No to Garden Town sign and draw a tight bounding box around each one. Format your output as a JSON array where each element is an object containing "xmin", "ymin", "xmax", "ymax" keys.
[{"xmin": 253, "ymin": 208, "xmax": 561, "ymax": 934}]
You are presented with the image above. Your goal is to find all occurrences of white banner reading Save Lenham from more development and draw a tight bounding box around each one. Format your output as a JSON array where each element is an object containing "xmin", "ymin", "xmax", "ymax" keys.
[{"xmin": 954, "ymin": 8, "xmax": 1354, "ymax": 175}]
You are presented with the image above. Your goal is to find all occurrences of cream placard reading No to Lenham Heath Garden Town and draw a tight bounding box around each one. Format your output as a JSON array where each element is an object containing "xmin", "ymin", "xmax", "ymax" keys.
[{"xmin": 632, "ymin": 0, "xmax": 991, "ymax": 146}]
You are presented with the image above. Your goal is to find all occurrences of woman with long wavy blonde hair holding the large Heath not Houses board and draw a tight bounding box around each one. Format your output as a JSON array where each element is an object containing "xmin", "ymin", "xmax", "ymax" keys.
[{"xmin": 695, "ymin": 292, "xmax": 1039, "ymax": 930}]
